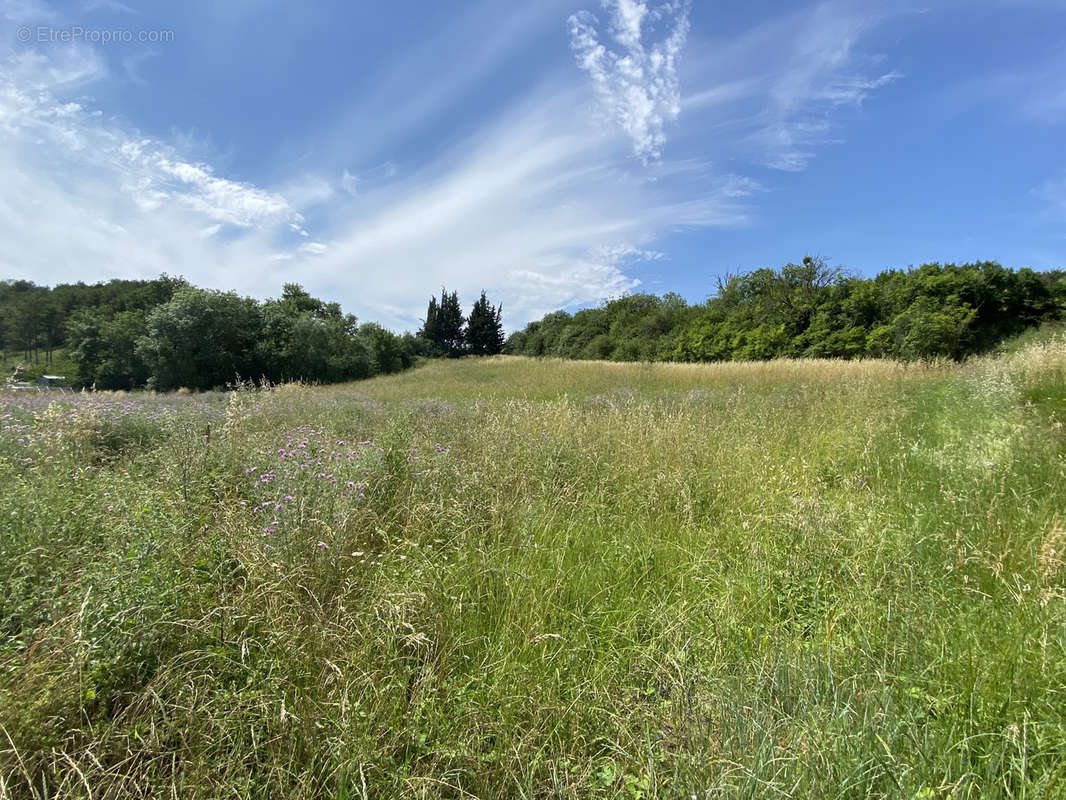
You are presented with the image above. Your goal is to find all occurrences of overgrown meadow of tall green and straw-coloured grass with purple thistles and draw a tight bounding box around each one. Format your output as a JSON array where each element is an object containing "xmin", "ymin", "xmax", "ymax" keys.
[{"xmin": 0, "ymin": 337, "xmax": 1066, "ymax": 800}]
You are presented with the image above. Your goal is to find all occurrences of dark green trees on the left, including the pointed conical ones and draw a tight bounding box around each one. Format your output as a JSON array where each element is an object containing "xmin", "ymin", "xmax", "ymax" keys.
[{"xmin": 0, "ymin": 275, "xmax": 503, "ymax": 390}]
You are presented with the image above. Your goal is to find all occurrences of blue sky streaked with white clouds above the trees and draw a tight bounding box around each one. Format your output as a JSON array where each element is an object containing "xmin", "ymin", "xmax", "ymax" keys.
[{"xmin": 0, "ymin": 0, "xmax": 1066, "ymax": 331}]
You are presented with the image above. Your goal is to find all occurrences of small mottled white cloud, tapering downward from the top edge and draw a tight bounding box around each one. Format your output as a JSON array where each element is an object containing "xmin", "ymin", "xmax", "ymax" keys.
[{"xmin": 569, "ymin": 0, "xmax": 689, "ymax": 161}]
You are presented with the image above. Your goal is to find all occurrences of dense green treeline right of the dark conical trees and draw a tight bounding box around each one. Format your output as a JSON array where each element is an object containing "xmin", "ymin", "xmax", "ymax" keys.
[{"xmin": 503, "ymin": 257, "xmax": 1066, "ymax": 362}]
